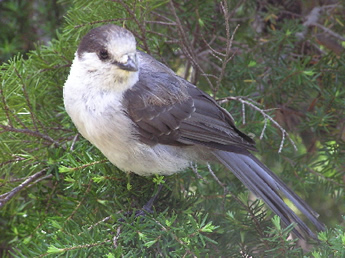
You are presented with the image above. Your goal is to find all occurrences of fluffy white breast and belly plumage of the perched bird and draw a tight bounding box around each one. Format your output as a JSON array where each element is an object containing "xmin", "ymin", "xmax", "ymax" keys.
[{"xmin": 64, "ymin": 53, "xmax": 190, "ymax": 176}]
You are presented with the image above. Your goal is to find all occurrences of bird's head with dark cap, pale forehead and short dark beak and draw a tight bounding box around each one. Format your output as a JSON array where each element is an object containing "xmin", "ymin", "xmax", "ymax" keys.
[{"xmin": 76, "ymin": 24, "xmax": 139, "ymax": 89}]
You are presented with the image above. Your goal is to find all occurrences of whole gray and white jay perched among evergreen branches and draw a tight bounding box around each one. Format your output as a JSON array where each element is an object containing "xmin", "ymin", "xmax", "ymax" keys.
[{"xmin": 63, "ymin": 24, "xmax": 324, "ymax": 238}]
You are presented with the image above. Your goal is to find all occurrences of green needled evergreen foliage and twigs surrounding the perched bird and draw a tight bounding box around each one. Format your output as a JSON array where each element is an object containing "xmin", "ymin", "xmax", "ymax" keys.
[{"xmin": 0, "ymin": 0, "xmax": 345, "ymax": 258}]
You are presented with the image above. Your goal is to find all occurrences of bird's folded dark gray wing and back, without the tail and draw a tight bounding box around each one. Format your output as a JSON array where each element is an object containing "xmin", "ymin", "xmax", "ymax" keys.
[{"xmin": 123, "ymin": 52, "xmax": 255, "ymax": 152}]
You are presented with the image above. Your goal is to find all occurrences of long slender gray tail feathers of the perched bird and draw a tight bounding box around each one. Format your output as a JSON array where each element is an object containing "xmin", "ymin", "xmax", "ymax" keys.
[{"xmin": 213, "ymin": 150, "xmax": 325, "ymax": 239}]
